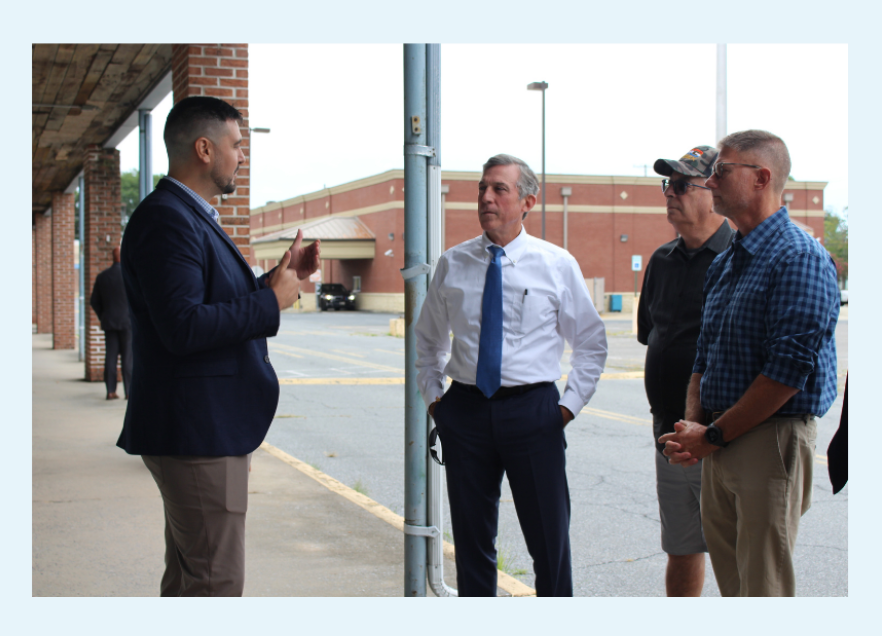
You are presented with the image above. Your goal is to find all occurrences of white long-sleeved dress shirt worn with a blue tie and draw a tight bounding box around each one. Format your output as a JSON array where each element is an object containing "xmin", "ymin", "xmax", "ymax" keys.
[{"xmin": 415, "ymin": 228, "xmax": 607, "ymax": 416}]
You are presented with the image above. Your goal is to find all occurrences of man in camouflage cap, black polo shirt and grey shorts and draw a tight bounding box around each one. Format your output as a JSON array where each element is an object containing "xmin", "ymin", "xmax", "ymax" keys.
[{"xmin": 637, "ymin": 146, "xmax": 734, "ymax": 596}]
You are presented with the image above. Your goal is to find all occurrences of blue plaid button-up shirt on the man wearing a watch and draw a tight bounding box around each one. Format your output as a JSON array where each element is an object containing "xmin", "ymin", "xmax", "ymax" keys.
[{"xmin": 692, "ymin": 208, "xmax": 839, "ymax": 415}]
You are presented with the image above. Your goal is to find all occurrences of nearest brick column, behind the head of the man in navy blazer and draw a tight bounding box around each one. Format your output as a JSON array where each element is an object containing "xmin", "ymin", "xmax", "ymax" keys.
[{"xmin": 172, "ymin": 44, "xmax": 256, "ymax": 264}]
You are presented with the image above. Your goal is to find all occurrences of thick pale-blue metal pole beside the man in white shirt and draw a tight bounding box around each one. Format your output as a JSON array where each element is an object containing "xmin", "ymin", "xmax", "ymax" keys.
[{"xmin": 403, "ymin": 44, "xmax": 428, "ymax": 597}]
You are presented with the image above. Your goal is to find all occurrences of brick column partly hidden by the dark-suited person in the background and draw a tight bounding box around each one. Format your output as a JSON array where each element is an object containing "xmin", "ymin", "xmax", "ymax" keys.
[{"xmin": 82, "ymin": 144, "xmax": 122, "ymax": 382}]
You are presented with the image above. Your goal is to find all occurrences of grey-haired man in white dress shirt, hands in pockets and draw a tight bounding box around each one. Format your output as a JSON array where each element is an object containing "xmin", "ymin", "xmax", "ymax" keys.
[{"xmin": 416, "ymin": 155, "xmax": 607, "ymax": 596}]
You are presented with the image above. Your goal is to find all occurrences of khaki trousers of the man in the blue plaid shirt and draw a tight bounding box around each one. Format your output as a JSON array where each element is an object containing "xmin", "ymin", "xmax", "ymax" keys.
[{"xmin": 701, "ymin": 417, "xmax": 817, "ymax": 596}]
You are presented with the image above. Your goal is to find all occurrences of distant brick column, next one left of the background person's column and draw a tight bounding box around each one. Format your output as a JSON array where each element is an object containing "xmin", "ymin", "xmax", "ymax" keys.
[{"xmin": 52, "ymin": 192, "xmax": 77, "ymax": 349}]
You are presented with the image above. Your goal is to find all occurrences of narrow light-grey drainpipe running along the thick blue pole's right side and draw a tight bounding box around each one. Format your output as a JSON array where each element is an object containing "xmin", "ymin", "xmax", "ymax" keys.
[{"xmin": 424, "ymin": 44, "xmax": 457, "ymax": 596}]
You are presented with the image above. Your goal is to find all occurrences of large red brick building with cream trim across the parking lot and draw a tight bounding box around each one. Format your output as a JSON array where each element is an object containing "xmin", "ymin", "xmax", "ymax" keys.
[{"xmin": 251, "ymin": 170, "xmax": 827, "ymax": 312}]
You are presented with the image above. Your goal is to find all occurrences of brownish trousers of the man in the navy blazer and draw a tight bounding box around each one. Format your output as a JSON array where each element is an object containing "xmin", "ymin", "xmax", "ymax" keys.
[{"xmin": 141, "ymin": 453, "xmax": 251, "ymax": 596}]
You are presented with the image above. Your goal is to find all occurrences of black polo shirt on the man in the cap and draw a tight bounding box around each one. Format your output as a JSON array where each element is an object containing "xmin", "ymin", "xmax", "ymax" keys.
[{"xmin": 637, "ymin": 221, "xmax": 735, "ymax": 452}]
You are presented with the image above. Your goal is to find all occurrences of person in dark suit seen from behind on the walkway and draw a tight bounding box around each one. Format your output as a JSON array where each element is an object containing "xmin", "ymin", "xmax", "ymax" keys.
[{"xmin": 89, "ymin": 247, "xmax": 132, "ymax": 400}]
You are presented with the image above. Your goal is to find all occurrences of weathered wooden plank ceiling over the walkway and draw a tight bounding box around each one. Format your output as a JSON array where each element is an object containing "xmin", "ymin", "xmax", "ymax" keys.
[{"xmin": 31, "ymin": 44, "xmax": 172, "ymax": 219}]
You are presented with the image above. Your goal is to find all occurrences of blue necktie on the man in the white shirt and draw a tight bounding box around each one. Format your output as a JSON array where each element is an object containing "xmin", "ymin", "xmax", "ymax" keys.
[{"xmin": 476, "ymin": 245, "xmax": 505, "ymax": 397}]
